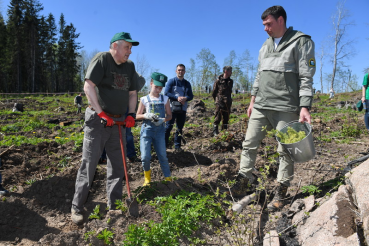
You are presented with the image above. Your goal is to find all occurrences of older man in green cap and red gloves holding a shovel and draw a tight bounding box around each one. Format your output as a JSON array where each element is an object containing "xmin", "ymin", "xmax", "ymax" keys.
[{"xmin": 71, "ymin": 32, "xmax": 139, "ymax": 224}]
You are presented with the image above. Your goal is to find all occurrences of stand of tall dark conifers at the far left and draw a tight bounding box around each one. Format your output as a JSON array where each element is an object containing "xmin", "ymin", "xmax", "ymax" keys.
[{"xmin": 0, "ymin": 0, "xmax": 82, "ymax": 93}]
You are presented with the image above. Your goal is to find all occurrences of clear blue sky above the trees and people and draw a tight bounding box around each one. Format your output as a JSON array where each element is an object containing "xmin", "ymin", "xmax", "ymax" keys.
[{"xmin": 0, "ymin": 0, "xmax": 369, "ymax": 91}]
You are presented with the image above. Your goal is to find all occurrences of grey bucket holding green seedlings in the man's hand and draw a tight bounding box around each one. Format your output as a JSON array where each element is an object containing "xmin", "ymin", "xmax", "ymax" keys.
[{"xmin": 276, "ymin": 121, "xmax": 315, "ymax": 162}]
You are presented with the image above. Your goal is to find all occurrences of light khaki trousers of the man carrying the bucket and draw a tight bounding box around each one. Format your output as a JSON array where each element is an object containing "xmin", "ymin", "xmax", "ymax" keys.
[{"xmin": 239, "ymin": 108, "xmax": 299, "ymax": 186}]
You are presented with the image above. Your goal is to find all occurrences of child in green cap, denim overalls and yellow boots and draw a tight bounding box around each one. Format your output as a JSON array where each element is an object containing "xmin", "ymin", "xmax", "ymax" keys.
[{"xmin": 137, "ymin": 72, "xmax": 172, "ymax": 186}]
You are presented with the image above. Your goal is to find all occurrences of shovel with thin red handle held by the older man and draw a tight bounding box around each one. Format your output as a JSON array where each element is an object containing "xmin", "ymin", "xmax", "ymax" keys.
[{"xmin": 101, "ymin": 119, "xmax": 139, "ymax": 218}]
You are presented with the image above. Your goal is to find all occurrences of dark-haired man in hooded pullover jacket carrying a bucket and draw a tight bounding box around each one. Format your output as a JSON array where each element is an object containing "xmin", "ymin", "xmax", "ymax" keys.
[{"xmin": 231, "ymin": 6, "xmax": 316, "ymax": 211}]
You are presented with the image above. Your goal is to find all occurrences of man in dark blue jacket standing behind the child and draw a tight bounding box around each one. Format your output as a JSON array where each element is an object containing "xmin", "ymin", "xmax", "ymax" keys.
[{"xmin": 164, "ymin": 64, "xmax": 193, "ymax": 152}]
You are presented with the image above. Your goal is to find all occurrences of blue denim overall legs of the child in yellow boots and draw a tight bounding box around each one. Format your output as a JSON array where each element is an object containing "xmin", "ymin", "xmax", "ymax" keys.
[{"xmin": 140, "ymin": 121, "xmax": 171, "ymax": 177}]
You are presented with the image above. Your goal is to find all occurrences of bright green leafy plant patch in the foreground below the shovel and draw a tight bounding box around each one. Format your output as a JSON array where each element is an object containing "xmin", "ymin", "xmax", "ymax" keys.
[{"xmin": 123, "ymin": 190, "xmax": 224, "ymax": 245}]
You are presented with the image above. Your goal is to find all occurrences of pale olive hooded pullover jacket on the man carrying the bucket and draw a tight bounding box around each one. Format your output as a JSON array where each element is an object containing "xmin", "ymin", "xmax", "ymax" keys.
[{"xmin": 251, "ymin": 27, "xmax": 316, "ymax": 113}]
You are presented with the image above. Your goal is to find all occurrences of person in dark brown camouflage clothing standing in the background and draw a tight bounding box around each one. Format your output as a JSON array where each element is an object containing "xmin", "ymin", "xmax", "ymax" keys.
[{"xmin": 212, "ymin": 66, "xmax": 233, "ymax": 136}]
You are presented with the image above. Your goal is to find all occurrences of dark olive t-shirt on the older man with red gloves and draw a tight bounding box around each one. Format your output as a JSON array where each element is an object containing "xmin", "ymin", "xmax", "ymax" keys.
[{"xmin": 85, "ymin": 52, "xmax": 137, "ymax": 114}]
